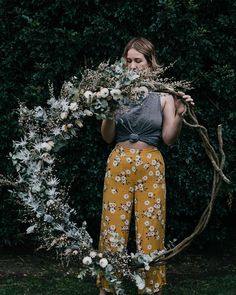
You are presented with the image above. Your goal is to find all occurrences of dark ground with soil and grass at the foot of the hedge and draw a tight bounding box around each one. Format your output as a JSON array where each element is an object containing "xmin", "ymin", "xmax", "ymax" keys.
[{"xmin": 0, "ymin": 242, "xmax": 236, "ymax": 295}]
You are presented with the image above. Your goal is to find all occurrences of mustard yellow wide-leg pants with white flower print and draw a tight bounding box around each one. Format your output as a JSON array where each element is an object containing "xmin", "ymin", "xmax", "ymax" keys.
[{"xmin": 98, "ymin": 146, "xmax": 166, "ymax": 294}]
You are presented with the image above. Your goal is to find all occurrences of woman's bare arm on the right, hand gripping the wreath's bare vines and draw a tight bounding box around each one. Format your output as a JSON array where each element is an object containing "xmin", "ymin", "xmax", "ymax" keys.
[{"xmin": 161, "ymin": 94, "xmax": 194, "ymax": 145}]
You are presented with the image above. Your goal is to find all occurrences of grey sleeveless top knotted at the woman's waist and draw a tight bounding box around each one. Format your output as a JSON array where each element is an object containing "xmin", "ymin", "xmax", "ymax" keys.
[{"xmin": 115, "ymin": 92, "xmax": 163, "ymax": 147}]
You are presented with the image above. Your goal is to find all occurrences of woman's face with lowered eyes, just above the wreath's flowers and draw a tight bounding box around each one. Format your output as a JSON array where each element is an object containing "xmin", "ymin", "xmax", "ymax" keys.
[{"xmin": 126, "ymin": 48, "xmax": 149, "ymax": 70}]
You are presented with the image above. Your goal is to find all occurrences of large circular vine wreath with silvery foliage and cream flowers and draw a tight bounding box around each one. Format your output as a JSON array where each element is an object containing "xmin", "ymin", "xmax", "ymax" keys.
[{"xmin": 10, "ymin": 60, "xmax": 229, "ymax": 294}]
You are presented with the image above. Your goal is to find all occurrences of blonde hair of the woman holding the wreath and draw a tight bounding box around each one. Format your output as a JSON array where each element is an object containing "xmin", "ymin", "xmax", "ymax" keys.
[{"xmin": 123, "ymin": 37, "xmax": 159, "ymax": 70}]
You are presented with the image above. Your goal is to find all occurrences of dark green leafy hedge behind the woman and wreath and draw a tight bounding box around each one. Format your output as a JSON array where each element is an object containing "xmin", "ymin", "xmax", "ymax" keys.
[{"xmin": 0, "ymin": 0, "xmax": 236, "ymax": 249}]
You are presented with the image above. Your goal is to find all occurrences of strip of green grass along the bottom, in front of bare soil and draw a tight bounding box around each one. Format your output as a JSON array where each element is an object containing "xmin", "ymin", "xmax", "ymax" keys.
[{"xmin": 0, "ymin": 272, "xmax": 236, "ymax": 295}]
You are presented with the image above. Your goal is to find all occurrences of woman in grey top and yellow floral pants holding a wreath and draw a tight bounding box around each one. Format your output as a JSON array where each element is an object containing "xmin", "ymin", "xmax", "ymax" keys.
[{"xmin": 99, "ymin": 38, "xmax": 194, "ymax": 295}]
